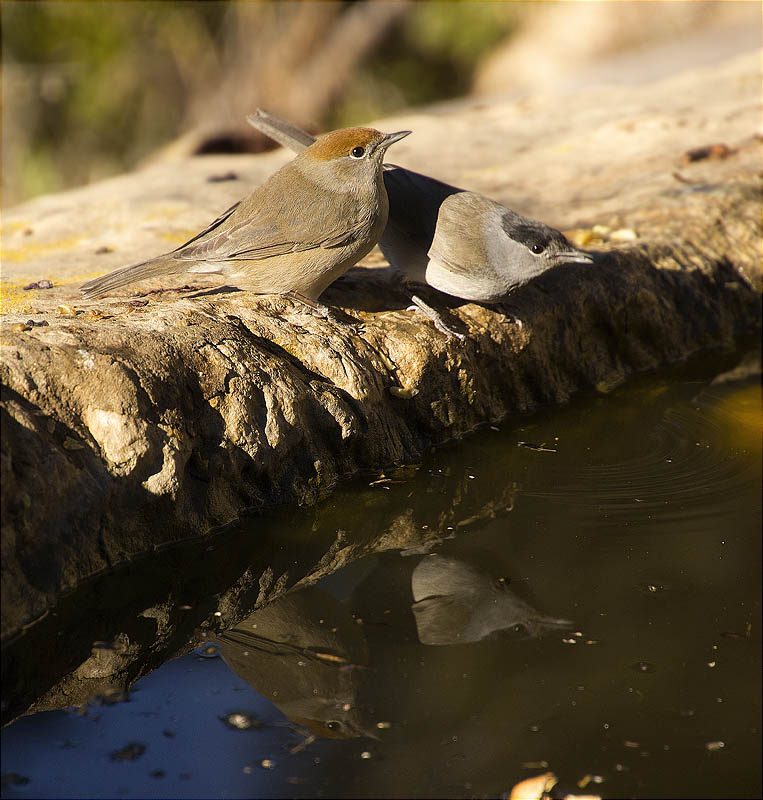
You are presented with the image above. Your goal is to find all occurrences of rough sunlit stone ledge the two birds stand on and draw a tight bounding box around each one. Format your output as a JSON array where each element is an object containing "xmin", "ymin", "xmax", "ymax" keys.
[{"xmin": 0, "ymin": 48, "xmax": 761, "ymax": 637}]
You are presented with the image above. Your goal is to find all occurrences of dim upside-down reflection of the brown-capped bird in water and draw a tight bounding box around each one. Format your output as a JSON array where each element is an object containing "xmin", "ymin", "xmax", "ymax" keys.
[{"xmin": 219, "ymin": 586, "xmax": 378, "ymax": 739}]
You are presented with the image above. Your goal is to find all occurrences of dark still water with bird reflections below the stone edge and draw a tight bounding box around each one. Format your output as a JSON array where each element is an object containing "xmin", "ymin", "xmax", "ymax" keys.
[{"xmin": 2, "ymin": 354, "xmax": 761, "ymax": 798}]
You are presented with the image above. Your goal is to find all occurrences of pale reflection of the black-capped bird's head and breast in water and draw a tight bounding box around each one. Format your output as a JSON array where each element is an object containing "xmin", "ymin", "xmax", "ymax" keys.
[{"xmin": 411, "ymin": 555, "xmax": 574, "ymax": 645}]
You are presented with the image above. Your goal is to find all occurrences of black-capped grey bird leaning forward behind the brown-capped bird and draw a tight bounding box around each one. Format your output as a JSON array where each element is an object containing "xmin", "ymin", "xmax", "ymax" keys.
[{"xmin": 247, "ymin": 110, "xmax": 593, "ymax": 303}]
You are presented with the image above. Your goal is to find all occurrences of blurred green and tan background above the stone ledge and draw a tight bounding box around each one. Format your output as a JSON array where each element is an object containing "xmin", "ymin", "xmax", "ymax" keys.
[{"xmin": 0, "ymin": 0, "xmax": 761, "ymax": 207}]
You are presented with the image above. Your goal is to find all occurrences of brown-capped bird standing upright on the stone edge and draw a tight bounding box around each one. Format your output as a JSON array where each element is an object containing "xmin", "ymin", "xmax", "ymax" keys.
[{"xmin": 81, "ymin": 128, "xmax": 410, "ymax": 305}]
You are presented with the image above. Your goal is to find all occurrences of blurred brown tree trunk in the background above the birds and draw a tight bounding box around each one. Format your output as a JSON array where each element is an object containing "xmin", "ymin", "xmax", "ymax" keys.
[{"xmin": 157, "ymin": 0, "xmax": 409, "ymax": 157}]
